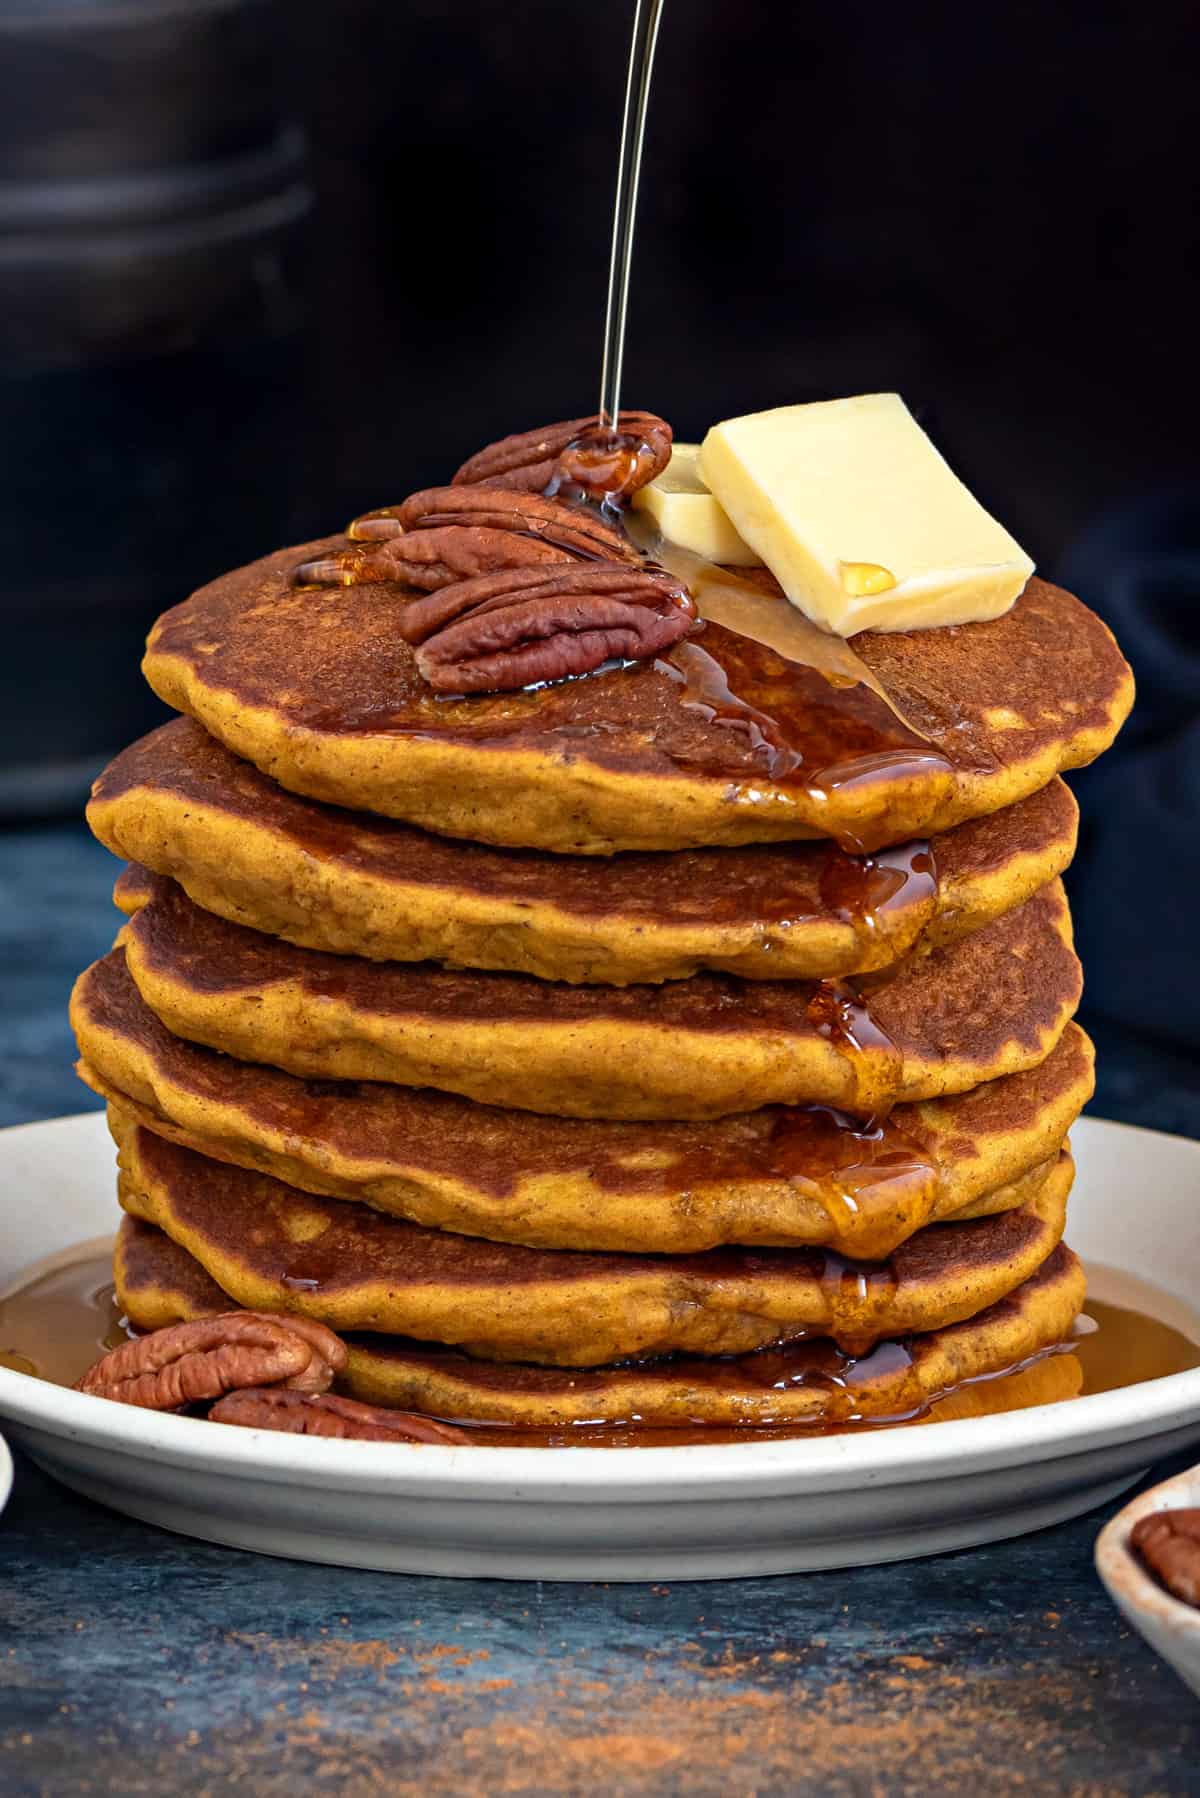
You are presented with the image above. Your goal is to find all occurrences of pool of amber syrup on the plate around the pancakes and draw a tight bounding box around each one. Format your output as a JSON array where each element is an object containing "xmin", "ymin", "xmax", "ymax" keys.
[{"xmin": 0, "ymin": 1244, "xmax": 1200, "ymax": 1447}]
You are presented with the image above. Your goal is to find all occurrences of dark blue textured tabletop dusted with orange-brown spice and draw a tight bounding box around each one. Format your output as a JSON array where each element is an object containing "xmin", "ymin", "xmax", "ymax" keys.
[{"xmin": 0, "ymin": 827, "xmax": 1200, "ymax": 1798}]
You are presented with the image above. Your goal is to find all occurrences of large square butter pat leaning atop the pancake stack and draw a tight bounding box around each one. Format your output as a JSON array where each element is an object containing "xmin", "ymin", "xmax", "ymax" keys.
[{"xmin": 698, "ymin": 394, "xmax": 1033, "ymax": 636}]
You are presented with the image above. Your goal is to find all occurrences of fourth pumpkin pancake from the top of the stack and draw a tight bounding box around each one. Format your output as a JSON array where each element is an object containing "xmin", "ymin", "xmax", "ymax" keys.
[{"xmin": 72, "ymin": 949, "xmax": 1092, "ymax": 1260}]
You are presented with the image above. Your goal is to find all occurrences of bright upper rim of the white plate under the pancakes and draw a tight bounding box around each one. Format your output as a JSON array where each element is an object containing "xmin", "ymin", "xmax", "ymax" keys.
[{"xmin": 0, "ymin": 1111, "xmax": 1200, "ymax": 1503}]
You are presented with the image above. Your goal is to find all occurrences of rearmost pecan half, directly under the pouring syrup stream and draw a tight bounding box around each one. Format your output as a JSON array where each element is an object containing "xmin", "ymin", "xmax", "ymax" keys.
[{"xmin": 453, "ymin": 412, "xmax": 671, "ymax": 500}]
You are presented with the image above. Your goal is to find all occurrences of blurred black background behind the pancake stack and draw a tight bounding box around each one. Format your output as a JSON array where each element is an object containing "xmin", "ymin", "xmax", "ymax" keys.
[{"xmin": 0, "ymin": 0, "xmax": 1200, "ymax": 1133}]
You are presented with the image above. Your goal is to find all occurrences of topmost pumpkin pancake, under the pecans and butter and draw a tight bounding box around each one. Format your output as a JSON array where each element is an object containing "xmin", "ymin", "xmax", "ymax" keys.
[{"xmin": 144, "ymin": 538, "xmax": 1133, "ymax": 854}]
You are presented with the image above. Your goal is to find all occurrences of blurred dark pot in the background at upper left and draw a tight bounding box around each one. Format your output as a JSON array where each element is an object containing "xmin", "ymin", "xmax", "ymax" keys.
[{"xmin": 0, "ymin": 0, "xmax": 311, "ymax": 816}]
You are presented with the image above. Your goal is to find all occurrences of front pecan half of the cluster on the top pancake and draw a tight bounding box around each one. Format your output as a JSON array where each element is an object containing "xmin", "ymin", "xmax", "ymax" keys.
[{"xmin": 399, "ymin": 563, "xmax": 696, "ymax": 692}]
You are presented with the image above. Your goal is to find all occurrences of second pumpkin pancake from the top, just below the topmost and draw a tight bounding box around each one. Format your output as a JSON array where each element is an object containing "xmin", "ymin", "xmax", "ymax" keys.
[{"xmin": 88, "ymin": 717, "xmax": 1078, "ymax": 985}]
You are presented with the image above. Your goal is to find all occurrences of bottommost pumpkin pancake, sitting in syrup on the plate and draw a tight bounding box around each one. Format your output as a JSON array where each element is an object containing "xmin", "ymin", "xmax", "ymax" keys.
[{"xmin": 113, "ymin": 1215, "xmax": 1085, "ymax": 1444}]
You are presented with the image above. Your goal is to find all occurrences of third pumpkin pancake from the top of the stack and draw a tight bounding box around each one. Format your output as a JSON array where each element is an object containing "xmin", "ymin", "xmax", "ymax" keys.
[{"xmin": 122, "ymin": 881, "xmax": 1079, "ymax": 1120}]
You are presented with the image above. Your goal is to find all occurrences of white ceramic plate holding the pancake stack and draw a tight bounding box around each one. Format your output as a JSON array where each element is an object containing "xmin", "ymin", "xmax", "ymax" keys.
[{"xmin": 0, "ymin": 1113, "xmax": 1200, "ymax": 1580}]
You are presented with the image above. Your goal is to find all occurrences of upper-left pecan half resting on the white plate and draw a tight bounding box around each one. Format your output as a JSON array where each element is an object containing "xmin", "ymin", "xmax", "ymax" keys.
[{"xmin": 76, "ymin": 1311, "xmax": 347, "ymax": 1411}]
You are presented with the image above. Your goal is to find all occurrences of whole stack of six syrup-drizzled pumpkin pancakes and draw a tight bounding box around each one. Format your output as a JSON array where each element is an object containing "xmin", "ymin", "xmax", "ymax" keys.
[{"xmin": 72, "ymin": 417, "xmax": 1132, "ymax": 1440}]
